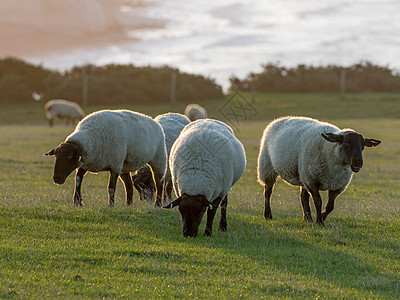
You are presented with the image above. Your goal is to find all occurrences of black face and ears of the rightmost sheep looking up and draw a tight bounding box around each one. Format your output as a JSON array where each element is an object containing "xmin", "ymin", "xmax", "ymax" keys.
[{"xmin": 321, "ymin": 131, "xmax": 381, "ymax": 173}]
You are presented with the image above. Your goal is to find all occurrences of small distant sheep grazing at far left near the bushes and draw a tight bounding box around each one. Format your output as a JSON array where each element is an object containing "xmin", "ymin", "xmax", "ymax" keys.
[{"xmin": 44, "ymin": 99, "xmax": 86, "ymax": 126}]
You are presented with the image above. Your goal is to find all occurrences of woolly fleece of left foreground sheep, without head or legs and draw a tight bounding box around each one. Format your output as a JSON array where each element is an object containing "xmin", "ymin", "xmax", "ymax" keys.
[{"xmin": 67, "ymin": 110, "xmax": 166, "ymax": 176}]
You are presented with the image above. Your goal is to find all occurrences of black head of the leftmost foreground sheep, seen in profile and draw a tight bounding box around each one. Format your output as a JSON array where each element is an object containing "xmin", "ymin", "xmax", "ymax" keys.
[{"xmin": 44, "ymin": 142, "xmax": 82, "ymax": 184}]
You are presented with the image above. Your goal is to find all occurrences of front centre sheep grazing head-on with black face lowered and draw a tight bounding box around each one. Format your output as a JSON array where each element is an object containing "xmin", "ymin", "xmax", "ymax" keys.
[{"xmin": 164, "ymin": 119, "xmax": 246, "ymax": 237}]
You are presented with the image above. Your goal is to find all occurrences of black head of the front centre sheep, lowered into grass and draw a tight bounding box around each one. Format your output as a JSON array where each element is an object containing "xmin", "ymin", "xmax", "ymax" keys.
[{"xmin": 164, "ymin": 194, "xmax": 212, "ymax": 237}]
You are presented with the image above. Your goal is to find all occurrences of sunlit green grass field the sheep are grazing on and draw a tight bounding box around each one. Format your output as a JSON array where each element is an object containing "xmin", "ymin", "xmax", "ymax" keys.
[{"xmin": 0, "ymin": 94, "xmax": 400, "ymax": 299}]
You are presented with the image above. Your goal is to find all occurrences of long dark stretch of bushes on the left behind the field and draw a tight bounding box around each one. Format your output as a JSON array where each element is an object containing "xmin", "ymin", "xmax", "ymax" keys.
[{"xmin": 0, "ymin": 57, "xmax": 223, "ymax": 104}]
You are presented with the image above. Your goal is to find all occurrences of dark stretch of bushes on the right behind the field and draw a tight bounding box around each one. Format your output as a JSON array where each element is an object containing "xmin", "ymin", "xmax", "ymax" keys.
[{"xmin": 229, "ymin": 61, "xmax": 400, "ymax": 93}]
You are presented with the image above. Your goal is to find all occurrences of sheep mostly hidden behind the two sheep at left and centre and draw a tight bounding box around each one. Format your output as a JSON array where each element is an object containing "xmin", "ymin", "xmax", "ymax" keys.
[{"xmin": 132, "ymin": 113, "xmax": 190, "ymax": 200}]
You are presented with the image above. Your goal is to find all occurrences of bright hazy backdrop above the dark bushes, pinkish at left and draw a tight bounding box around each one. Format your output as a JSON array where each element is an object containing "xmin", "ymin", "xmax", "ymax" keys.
[{"xmin": 0, "ymin": 0, "xmax": 400, "ymax": 89}]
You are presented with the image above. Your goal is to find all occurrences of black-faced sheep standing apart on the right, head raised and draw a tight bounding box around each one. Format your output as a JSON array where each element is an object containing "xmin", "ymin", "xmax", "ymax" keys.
[{"xmin": 257, "ymin": 117, "xmax": 381, "ymax": 225}]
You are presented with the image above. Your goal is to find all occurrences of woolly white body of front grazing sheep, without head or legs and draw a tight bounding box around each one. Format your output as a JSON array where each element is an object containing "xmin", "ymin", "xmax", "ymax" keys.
[{"xmin": 169, "ymin": 119, "xmax": 246, "ymax": 201}]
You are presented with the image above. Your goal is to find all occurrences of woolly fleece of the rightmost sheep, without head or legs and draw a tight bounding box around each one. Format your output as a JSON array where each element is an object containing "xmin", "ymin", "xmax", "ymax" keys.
[{"xmin": 257, "ymin": 117, "xmax": 353, "ymax": 190}]
